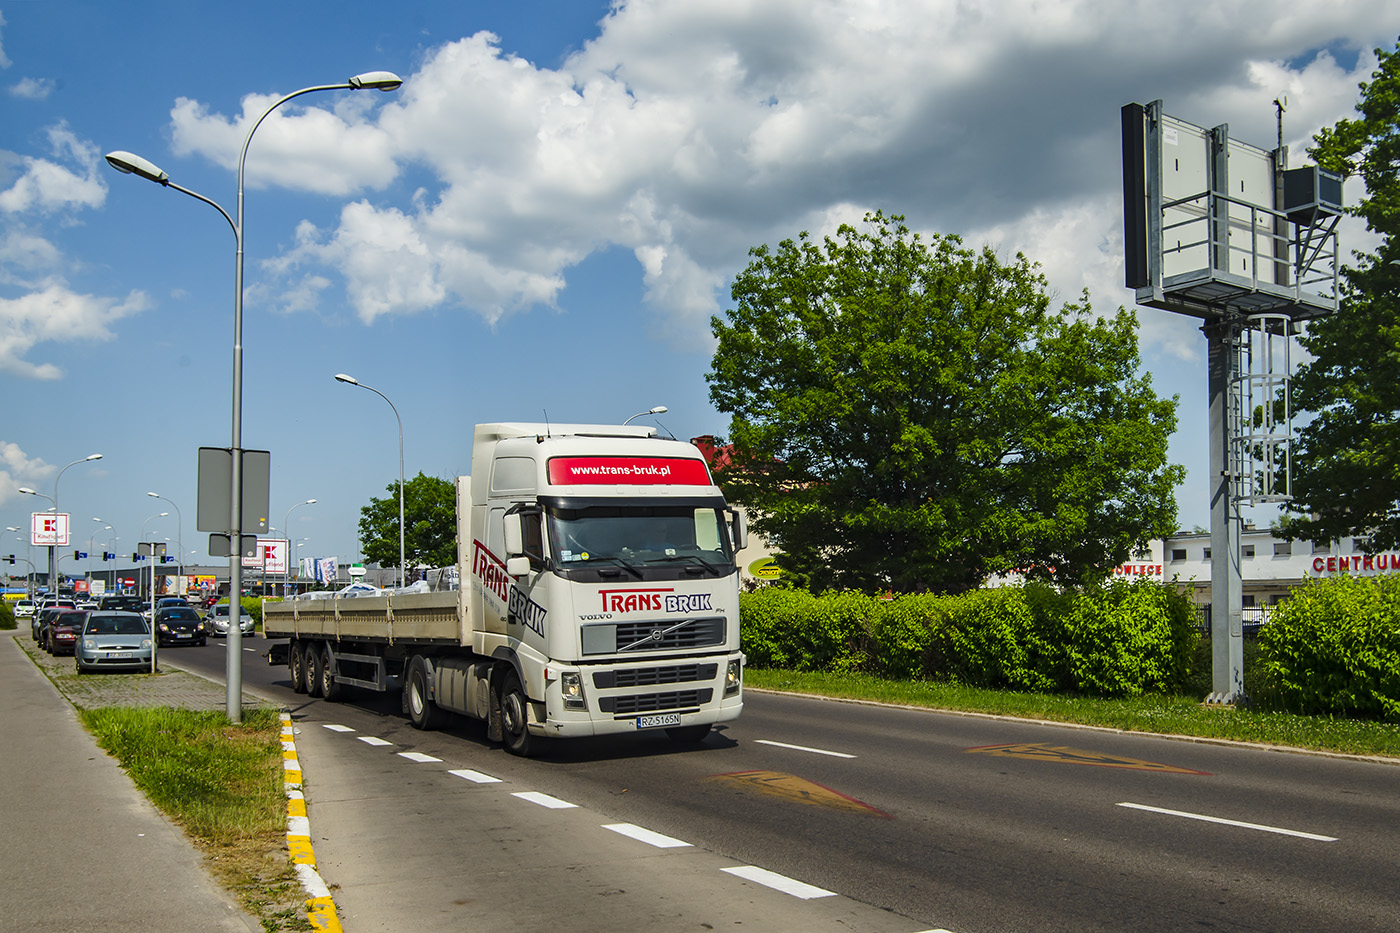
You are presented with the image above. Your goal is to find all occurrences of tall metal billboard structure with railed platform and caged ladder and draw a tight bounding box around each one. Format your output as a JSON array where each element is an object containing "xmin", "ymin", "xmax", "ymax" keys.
[{"xmin": 1121, "ymin": 101, "xmax": 1341, "ymax": 703}]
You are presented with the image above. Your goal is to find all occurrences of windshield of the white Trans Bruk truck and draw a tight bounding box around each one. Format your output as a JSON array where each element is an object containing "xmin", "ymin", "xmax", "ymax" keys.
[{"xmin": 546, "ymin": 504, "xmax": 734, "ymax": 574}]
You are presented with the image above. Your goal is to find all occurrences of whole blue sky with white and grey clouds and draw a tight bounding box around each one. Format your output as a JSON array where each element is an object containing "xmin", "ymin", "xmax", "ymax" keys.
[{"xmin": 0, "ymin": 0, "xmax": 1400, "ymax": 572}]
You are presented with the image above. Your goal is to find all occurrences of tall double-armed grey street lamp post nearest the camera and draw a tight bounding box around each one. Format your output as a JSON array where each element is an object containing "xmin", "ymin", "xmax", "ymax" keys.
[{"xmin": 106, "ymin": 71, "xmax": 403, "ymax": 723}]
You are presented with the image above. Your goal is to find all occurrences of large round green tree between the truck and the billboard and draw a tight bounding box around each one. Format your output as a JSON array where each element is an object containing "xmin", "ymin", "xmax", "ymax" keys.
[{"xmin": 707, "ymin": 213, "xmax": 1183, "ymax": 593}]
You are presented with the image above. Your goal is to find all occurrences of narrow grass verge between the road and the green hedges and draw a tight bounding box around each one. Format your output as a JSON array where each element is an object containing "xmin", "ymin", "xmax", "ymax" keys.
[{"xmin": 743, "ymin": 668, "xmax": 1400, "ymax": 759}]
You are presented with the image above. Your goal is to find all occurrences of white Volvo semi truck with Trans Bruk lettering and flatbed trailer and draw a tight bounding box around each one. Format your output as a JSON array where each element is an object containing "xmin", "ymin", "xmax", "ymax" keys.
[{"xmin": 263, "ymin": 424, "xmax": 746, "ymax": 755}]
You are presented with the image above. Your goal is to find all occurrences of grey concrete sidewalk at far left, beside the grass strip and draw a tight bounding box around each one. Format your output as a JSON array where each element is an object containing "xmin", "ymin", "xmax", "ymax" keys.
[{"xmin": 0, "ymin": 621, "xmax": 262, "ymax": 933}]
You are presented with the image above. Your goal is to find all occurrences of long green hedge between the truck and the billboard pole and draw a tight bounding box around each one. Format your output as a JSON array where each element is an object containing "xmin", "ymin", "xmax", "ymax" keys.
[{"xmin": 739, "ymin": 581, "xmax": 1198, "ymax": 696}]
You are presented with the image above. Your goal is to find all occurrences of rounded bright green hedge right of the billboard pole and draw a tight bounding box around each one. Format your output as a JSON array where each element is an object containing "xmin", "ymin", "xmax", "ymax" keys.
[{"xmin": 1259, "ymin": 574, "xmax": 1400, "ymax": 721}]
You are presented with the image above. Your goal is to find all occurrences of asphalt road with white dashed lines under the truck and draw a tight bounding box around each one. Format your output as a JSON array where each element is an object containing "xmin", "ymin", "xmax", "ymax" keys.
[{"xmin": 172, "ymin": 637, "xmax": 1400, "ymax": 933}]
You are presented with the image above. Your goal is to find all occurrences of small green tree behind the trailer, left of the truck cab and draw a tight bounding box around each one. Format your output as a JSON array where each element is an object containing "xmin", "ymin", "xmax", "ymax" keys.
[{"xmin": 360, "ymin": 472, "xmax": 456, "ymax": 573}]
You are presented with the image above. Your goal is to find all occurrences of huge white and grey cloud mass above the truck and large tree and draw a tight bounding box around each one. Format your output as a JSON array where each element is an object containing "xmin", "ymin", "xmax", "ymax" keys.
[{"xmin": 172, "ymin": 0, "xmax": 1393, "ymax": 353}]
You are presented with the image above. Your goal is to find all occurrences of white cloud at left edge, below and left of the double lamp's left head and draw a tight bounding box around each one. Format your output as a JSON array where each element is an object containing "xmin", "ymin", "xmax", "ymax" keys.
[{"xmin": 0, "ymin": 284, "xmax": 148, "ymax": 380}]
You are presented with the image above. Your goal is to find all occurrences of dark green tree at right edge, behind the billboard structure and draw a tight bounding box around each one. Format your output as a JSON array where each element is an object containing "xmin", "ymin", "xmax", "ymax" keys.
[{"xmin": 1280, "ymin": 43, "xmax": 1400, "ymax": 548}]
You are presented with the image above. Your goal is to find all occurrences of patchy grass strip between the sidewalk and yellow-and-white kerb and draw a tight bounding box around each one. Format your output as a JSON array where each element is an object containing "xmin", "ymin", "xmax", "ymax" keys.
[{"xmin": 78, "ymin": 706, "xmax": 312, "ymax": 933}]
